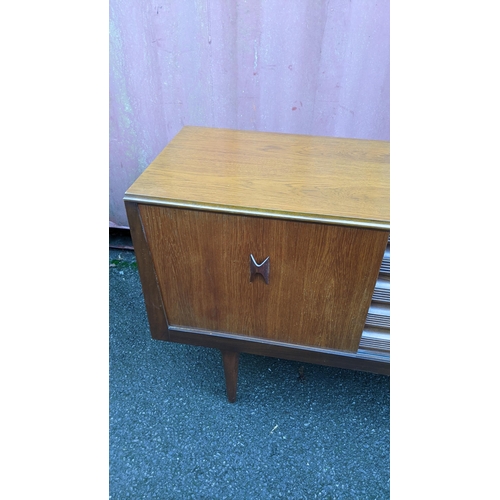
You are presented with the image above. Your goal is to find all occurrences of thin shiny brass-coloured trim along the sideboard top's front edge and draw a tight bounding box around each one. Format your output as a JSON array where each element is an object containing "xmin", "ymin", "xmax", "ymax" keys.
[{"xmin": 123, "ymin": 193, "xmax": 390, "ymax": 231}]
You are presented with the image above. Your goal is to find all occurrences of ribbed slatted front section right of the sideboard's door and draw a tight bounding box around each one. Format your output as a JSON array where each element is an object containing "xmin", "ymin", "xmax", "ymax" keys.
[{"xmin": 358, "ymin": 238, "xmax": 391, "ymax": 358}]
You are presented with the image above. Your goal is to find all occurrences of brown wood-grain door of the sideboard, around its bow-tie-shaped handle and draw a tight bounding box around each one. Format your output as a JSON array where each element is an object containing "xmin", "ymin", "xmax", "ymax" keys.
[{"xmin": 139, "ymin": 205, "xmax": 388, "ymax": 352}]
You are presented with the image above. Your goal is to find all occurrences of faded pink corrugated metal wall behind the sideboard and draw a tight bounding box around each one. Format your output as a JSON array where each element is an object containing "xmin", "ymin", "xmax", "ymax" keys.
[{"xmin": 109, "ymin": 0, "xmax": 389, "ymax": 227}]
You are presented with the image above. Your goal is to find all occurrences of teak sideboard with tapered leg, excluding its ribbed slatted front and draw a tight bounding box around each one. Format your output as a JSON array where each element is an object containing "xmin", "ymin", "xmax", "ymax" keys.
[{"xmin": 124, "ymin": 127, "xmax": 390, "ymax": 402}]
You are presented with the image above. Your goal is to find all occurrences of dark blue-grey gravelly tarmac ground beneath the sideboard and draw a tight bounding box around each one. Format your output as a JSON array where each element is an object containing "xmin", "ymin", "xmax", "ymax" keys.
[{"xmin": 109, "ymin": 249, "xmax": 390, "ymax": 500}]
